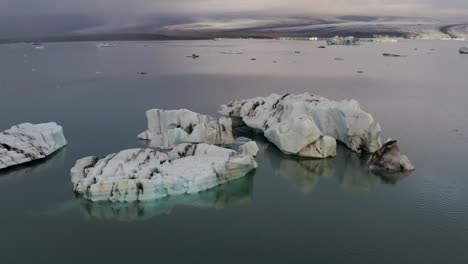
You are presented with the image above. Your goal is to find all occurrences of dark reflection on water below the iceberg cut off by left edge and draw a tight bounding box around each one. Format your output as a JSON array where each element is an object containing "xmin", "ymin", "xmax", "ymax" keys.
[{"xmin": 0, "ymin": 147, "xmax": 67, "ymax": 184}]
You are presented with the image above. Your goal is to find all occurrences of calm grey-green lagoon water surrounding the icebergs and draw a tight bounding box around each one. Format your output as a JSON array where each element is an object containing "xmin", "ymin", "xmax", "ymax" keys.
[{"xmin": 0, "ymin": 40, "xmax": 468, "ymax": 264}]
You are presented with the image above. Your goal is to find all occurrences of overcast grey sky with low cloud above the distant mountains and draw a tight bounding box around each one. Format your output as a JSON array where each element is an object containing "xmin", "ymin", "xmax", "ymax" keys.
[{"xmin": 0, "ymin": 0, "xmax": 468, "ymax": 35}]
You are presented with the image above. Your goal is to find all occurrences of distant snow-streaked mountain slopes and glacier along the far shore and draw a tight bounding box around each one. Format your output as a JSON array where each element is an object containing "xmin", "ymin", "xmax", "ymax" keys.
[{"xmin": 0, "ymin": 16, "xmax": 468, "ymax": 42}]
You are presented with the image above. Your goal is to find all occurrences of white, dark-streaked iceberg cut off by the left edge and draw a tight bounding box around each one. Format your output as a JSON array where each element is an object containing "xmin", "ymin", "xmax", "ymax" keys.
[{"xmin": 0, "ymin": 123, "xmax": 67, "ymax": 169}]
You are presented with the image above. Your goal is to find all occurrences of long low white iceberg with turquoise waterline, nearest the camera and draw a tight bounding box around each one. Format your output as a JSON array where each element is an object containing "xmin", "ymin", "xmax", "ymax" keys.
[{"xmin": 71, "ymin": 144, "xmax": 257, "ymax": 202}]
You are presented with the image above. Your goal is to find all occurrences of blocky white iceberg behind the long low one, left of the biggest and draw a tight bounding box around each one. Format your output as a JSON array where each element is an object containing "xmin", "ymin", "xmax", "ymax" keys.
[{"xmin": 138, "ymin": 109, "xmax": 234, "ymax": 149}]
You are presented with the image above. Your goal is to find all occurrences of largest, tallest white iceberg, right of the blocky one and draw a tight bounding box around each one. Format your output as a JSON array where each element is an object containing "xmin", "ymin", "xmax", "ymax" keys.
[{"xmin": 220, "ymin": 93, "xmax": 382, "ymax": 158}]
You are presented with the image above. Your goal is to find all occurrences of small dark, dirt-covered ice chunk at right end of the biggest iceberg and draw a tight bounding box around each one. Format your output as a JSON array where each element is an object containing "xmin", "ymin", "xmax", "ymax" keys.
[{"xmin": 369, "ymin": 139, "xmax": 415, "ymax": 172}]
